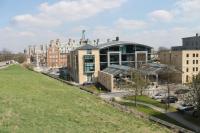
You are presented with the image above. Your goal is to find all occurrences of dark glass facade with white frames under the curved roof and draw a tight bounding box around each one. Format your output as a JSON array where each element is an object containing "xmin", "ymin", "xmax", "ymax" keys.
[{"xmin": 100, "ymin": 43, "xmax": 151, "ymax": 70}]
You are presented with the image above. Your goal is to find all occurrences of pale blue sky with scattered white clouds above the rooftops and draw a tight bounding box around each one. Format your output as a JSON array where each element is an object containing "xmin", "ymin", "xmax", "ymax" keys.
[{"xmin": 0, "ymin": 0, "xmax": 200, "ymax": 52}]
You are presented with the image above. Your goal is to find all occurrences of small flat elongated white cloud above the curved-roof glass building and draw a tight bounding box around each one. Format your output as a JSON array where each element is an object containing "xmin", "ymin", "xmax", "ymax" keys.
[{"xmin": 116, "ymin": 18, "xmax": 147, "ymax": 30}]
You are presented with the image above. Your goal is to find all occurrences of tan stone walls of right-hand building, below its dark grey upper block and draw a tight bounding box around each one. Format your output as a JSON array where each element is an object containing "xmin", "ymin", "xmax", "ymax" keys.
[{"xmin": 159, "ymin": 50, "xmax": 200, "ymax": 84}]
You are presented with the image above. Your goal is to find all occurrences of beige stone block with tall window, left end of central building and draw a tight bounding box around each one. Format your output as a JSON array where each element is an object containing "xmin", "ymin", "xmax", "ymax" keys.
[{"xmin": 67, "ymin": 44, "xmax": 100, "ymax": 84}]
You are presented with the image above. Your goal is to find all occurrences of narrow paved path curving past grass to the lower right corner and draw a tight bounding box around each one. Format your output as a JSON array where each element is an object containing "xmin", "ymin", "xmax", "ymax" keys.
[{"xmin": 123, "ymin": 100, "xmax": 200, "ymax": 132}]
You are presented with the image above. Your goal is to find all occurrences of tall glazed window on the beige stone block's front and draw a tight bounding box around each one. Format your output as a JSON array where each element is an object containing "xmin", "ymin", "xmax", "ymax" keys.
[{"xmin": 84, "ymin": 55, "xmax": 95, "ymax": 73}]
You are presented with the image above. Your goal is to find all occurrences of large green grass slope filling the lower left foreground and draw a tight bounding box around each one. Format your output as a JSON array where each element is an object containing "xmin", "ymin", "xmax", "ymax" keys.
[{"xmin": 0, "ymin": 65, "xmax": 170, "ymax": 133}]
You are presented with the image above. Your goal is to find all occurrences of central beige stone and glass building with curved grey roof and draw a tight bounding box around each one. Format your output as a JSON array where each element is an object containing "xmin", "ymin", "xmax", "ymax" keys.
[{"xmin": 67, "ymin": 38, "xmax": 152, "ymax": 84}]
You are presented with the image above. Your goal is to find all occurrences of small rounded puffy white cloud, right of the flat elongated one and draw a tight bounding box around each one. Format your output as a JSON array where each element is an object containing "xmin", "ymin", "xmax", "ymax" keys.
[{"xmin": 149, "ymin": 10, "xmax": 174, "ymax": 22}]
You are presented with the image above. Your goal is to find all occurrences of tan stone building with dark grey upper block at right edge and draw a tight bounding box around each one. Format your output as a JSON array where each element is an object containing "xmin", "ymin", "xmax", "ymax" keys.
[{"xmin": 158, "ymin": 34, "xmax": 200, "ymax": 84}]
